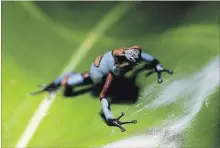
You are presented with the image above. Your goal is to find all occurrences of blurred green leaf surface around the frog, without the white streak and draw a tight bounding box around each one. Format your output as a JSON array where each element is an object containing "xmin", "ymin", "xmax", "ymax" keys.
[{"xmin": 2, "ymin": 1, "xmax": 220, "ymax": 148}]
